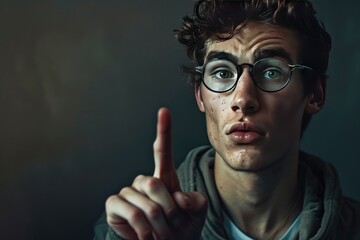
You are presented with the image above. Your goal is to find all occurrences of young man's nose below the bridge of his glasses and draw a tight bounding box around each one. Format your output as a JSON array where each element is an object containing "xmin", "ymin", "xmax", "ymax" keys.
[{"xmin": 231, "ymin": 68, "xmax": 260, "ymax": 115}]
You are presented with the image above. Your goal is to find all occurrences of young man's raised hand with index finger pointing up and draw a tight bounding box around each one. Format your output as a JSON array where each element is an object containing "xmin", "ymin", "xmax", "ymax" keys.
[{"xmin": 106, "ymin": 108, "xmax": 207, "ymax": 239}]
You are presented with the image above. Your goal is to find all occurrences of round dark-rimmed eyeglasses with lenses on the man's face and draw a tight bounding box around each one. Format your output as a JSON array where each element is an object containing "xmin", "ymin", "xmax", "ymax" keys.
[{"xmin": 195, "ymin": 58, "xmax": 313, "ymax": 93}]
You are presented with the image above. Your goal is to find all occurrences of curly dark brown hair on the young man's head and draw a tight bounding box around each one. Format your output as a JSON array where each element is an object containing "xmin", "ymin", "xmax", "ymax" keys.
[{"xmin": 175, "ymin": 0, "xmax": 331, "ymax": 135}]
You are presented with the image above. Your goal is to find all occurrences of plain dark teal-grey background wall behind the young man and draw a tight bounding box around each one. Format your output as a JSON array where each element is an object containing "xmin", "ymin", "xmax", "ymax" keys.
[{"xmin": 0, "ymin": 0, "xmax": 360, "ymax": 240}]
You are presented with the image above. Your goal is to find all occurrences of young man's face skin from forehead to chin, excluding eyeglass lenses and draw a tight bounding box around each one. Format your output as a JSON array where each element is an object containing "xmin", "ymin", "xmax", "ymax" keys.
[{"xmin": 195, "ymin": 22, "xmax": 319, "ymax": 171}]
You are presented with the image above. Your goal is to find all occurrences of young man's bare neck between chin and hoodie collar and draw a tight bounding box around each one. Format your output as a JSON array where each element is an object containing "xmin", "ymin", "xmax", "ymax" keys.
[{"xmin": 214, "ymin": 151, "xmax": 301, "ymax": 239}]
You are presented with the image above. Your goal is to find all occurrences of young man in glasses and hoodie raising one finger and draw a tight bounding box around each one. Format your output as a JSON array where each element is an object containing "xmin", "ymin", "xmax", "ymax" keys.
[{"xmin": 95, "ymin": 0, "xmax": 360, "ymax": 239}]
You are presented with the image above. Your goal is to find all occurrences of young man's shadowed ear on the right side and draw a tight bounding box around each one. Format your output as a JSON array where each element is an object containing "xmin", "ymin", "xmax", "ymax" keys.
[{"xmin": 305, "ymin": 79, "xmax": 326, "ymax": 114}]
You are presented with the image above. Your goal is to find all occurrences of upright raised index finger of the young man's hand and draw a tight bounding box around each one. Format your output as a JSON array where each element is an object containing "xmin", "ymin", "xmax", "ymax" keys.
[{"xmin": 154, "ymin": 108, "xmax": 180, "ymax": 193}]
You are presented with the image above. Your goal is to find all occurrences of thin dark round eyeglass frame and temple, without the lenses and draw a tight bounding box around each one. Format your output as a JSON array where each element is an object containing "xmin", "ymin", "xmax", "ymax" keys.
[{"xmin": 195, "ymin": 58, "xmax": 314, "ymax": 93}]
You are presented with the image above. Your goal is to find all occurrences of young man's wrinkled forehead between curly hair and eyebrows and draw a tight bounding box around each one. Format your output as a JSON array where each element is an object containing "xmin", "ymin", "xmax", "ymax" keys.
[{"xmin": 205, "ymin": 22, "xmax": 300, "ymax": 63}]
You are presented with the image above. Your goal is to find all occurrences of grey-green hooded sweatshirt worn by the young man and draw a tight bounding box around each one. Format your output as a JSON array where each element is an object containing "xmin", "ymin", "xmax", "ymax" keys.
[{"xmin": 94, "ymin": 146, "xmax": 360, "ymax": 240}]
